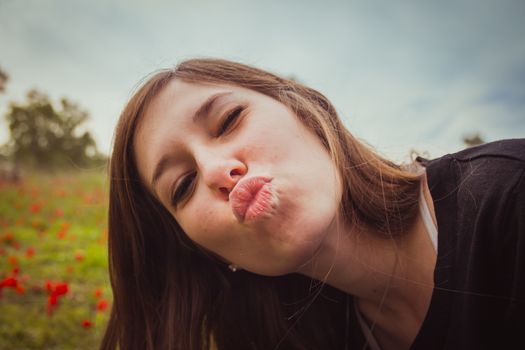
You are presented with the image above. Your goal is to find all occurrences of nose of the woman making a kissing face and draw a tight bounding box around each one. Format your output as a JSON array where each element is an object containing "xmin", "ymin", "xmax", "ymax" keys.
[{"xmin": 197, "ymin": 154, "xmax": 247, "ymax": 198}]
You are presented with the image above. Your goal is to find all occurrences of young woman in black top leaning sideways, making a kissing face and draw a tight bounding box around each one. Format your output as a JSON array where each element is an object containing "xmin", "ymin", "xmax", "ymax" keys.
[{"xmin": 102, "ymin": 59, "xmax": 525, "ymax": 350}]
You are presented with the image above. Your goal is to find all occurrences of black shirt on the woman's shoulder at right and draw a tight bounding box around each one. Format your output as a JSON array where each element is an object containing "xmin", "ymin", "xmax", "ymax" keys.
[{"xmin": 411, "ymin": 139, "xmax": 525, "ymax": 350}]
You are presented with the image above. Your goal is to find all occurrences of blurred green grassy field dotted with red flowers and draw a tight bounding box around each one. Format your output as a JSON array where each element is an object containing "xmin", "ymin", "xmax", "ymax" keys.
[{"xmin": 0, "ymin": 172, "xmax": 112, "ymax": 350}]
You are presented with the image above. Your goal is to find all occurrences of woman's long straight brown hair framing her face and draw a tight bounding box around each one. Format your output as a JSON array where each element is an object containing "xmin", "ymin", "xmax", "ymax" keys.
[{"xmin": 101, "ymin": 59, "xmax": 420, "ymax": 350}]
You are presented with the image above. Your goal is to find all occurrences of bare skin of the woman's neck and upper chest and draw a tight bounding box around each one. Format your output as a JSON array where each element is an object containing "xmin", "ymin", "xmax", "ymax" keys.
[{"xmin": 299, "ymin": 179, "xmax": 436, "ymax": 348}]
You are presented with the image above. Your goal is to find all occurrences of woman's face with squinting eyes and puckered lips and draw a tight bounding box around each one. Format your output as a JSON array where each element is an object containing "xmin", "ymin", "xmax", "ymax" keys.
[{"xmin": 133, "ymin": 80, "xmax": 341, "ymax": 275}]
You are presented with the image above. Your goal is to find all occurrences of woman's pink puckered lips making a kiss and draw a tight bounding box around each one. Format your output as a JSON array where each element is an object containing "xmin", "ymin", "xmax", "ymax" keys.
[{"xmin": 229, "ymin": 176, "xmax": 272, "ymax": 222}]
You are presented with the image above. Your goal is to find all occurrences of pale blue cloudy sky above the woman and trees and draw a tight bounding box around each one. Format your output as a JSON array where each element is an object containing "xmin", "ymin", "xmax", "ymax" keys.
[{"xmin": 0, "ymin": 0, "xmax": 525, "ymax": 161}]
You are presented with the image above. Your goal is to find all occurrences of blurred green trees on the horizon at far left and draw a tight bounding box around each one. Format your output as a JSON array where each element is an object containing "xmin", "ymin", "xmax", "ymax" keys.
[{"xmin": 0, "ymin": 68, "xmax": 107, "ymax": 170}]
